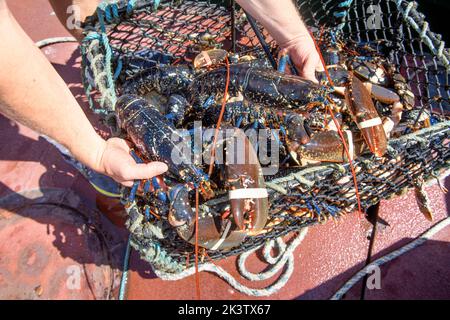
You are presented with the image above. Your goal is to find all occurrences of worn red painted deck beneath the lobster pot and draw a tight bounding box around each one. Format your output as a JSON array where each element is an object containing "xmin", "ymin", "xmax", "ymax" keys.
[{"xmin": 0, "ymin": 0, "xmax": 450, "ymax": 299}]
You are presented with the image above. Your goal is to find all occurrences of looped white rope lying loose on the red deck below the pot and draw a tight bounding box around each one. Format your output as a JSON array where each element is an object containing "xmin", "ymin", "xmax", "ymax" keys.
[{"xmin": 153, "ymin": 228, "xmax": 308, "ymax": 297}]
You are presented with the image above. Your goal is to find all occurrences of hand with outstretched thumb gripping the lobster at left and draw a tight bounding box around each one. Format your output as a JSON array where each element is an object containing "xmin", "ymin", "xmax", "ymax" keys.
[{"xmin": 94, "ymin": 138, "xmax": 168, "ymax": 187}]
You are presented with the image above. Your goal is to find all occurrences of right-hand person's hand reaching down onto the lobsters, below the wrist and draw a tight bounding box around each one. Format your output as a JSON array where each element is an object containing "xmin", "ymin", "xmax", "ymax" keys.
[{"xmin": 281, "ymin": 34, "xmax": 324, "ymax": 83}]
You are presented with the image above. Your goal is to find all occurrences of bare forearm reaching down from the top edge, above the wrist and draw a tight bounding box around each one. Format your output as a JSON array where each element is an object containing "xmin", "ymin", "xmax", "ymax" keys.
[{"xmin": 237, "ymin": 0, "xmax": 308, "ymax": 46}]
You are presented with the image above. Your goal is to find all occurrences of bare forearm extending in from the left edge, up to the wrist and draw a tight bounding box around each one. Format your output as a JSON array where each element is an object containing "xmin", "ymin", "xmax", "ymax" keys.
[{"xmin": 0, "ymin": 2, "xmax": 105, "ymax": 169}]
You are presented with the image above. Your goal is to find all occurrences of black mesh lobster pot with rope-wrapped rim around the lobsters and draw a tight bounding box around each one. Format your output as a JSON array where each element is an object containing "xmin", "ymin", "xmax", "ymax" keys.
[{"xmin": 81, "ymin": 0, "xmax": 450, "ymax": 272}]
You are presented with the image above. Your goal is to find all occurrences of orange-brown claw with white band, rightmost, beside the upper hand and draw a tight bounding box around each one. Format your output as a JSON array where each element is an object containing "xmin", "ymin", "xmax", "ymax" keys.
[{"xmin": 346, "ymin": 73, "xmax": 387, "ymax": 157}]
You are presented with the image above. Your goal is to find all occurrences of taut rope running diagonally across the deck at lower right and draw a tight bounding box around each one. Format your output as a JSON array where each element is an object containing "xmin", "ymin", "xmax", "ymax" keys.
[{"xmin": 331, "ymin": 217, "xmax": 450, "ymax": 300}]
